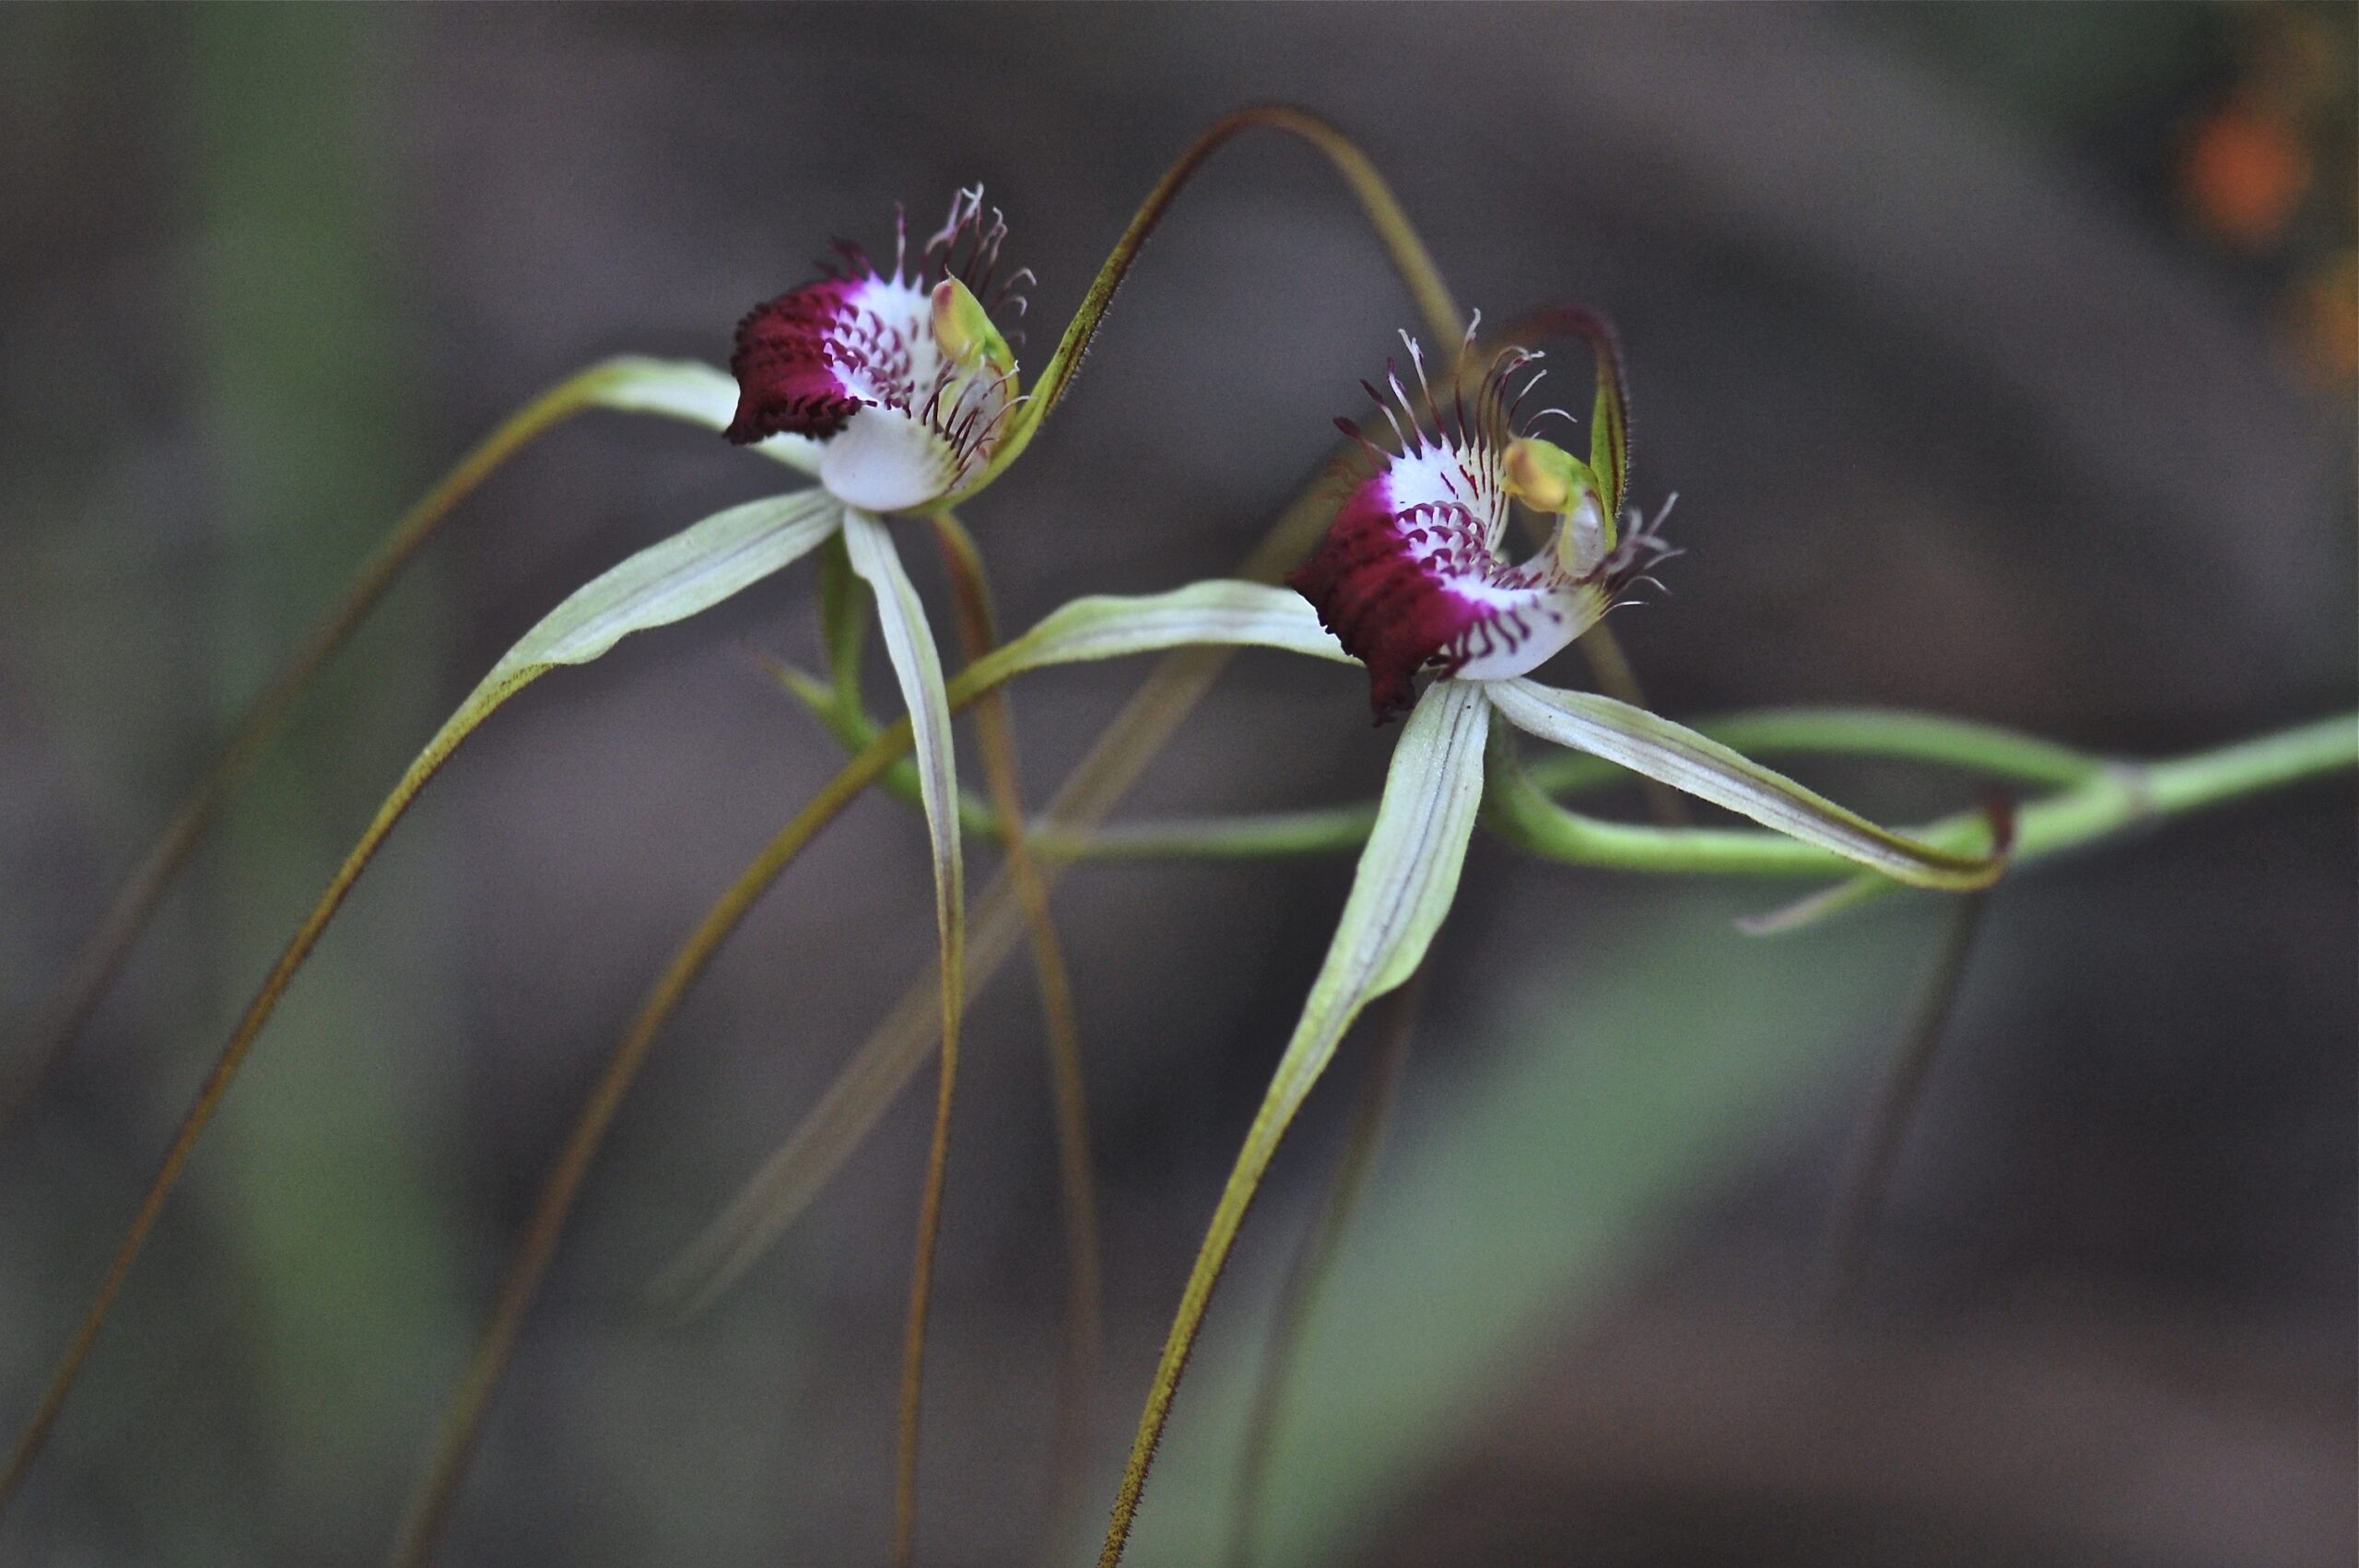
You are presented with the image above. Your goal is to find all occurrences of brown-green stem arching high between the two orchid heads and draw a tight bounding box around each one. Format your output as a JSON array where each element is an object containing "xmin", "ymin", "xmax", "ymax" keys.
[{"xmin": 941, "ymin": 104, "xmax": 1465, "ymax": 507}]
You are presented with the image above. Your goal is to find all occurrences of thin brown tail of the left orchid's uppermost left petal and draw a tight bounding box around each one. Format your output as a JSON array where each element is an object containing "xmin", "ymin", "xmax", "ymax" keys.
[{"xmin": 0, "ymin": 366, "xmax": 646, "ymax": 1131}]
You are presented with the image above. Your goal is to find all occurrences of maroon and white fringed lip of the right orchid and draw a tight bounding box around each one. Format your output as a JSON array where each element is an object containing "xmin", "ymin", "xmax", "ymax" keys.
[{"xmin": 1288, "ymin": 333, "xmax": 1668, "ymax": 724}]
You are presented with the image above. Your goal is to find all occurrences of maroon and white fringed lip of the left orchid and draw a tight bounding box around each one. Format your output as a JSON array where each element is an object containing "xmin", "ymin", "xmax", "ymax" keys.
[{"xmin": 724, "ymin": 186, "xmax": 1031, "ymax": 511}]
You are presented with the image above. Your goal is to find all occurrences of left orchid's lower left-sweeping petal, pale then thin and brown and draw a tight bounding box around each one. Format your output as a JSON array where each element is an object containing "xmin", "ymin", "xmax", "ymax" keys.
[{"xmin": 0, "ymin": 490, "xmax": 839, "ymax": 1504}]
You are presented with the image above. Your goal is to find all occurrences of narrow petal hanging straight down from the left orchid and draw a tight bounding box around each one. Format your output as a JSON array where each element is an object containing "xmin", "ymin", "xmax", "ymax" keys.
[{"xmin": 844, "ymin": 511, "xmax": 968, "ymax": 1563}]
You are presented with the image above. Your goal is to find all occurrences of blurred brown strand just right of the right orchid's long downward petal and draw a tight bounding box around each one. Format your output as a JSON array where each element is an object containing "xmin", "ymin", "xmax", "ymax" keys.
[{"xmin": 1229, "ymin": 966, "xmax": 1427, "ymax": 1568}]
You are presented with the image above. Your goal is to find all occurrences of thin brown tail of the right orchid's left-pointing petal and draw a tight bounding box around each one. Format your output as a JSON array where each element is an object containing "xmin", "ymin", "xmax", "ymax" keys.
[{"xmin": 392, "ymin": 720, "xmax": 910, "ymax": 1568}]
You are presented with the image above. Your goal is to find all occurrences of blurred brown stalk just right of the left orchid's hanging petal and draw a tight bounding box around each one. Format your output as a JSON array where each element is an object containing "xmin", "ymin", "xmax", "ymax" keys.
[{"xmin": 934, "ymin": 511, "xmax": 1104, "ymax": 1539}]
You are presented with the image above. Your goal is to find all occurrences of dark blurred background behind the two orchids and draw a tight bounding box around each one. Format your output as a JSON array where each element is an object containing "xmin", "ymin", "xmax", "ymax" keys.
[{"xmin": 0, "ymin": 5, "xmax": 2354, "ymax": 1568}]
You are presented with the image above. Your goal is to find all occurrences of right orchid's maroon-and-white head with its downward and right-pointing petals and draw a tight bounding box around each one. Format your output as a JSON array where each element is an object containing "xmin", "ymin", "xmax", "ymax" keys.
[{"xmin": 1099, "ymin": 316, "xmax": 2001, "ymax": 1563}]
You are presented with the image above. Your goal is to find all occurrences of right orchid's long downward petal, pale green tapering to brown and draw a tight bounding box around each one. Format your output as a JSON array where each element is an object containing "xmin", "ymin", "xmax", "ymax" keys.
[{"xmin": 1099, "ymin": 682, "xmax": 1491, "ymax": 1568}]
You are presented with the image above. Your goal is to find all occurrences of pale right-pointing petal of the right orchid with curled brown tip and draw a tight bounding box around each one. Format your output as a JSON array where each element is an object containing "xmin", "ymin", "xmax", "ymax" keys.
[{"xmin": 1486, "ymin": 679, "xmax": 2001, "ymax": 886}]
